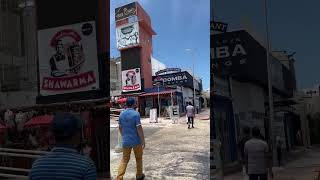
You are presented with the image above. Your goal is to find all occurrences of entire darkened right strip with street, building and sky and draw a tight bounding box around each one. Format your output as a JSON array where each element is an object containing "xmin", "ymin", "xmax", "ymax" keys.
[{"xmin": 210, "ymin": 0, "xmax": 320, "ymax": 180}]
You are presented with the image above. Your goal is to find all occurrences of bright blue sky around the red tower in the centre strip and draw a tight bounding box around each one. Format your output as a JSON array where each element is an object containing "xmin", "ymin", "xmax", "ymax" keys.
[{"xmin": 110, "ymin": 0, "xmax": 210, "ymax": 89}]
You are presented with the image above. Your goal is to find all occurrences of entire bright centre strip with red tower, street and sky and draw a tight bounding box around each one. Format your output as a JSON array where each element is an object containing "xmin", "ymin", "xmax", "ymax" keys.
[{"xmin": 110, "ymin": 0, "xmax": 210, "ymax": 180}]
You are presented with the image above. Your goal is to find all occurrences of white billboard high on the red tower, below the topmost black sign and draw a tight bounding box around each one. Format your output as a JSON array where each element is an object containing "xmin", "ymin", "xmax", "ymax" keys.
[{"xmin": 116, "ymin": 22, "xmax": 140, "ymax": 50}]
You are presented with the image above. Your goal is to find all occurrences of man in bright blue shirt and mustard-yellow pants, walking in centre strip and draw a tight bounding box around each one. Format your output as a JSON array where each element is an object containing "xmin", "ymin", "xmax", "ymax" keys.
[{"xmin": 117, "ymin": 98, "xmax": 145, "ymax": 180}]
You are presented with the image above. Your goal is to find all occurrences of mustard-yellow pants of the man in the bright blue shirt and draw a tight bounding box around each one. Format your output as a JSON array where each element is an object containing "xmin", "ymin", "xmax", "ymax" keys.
[{"xmin": 117, "ymin": 145, "xmax": 143, "ymax": 180}]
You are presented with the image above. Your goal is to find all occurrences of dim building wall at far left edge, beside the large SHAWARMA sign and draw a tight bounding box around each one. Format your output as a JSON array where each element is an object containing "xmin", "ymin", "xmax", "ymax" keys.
[{"xmin": 0, "ymin": 0, "xmax": 37, "ymax": 109}]
